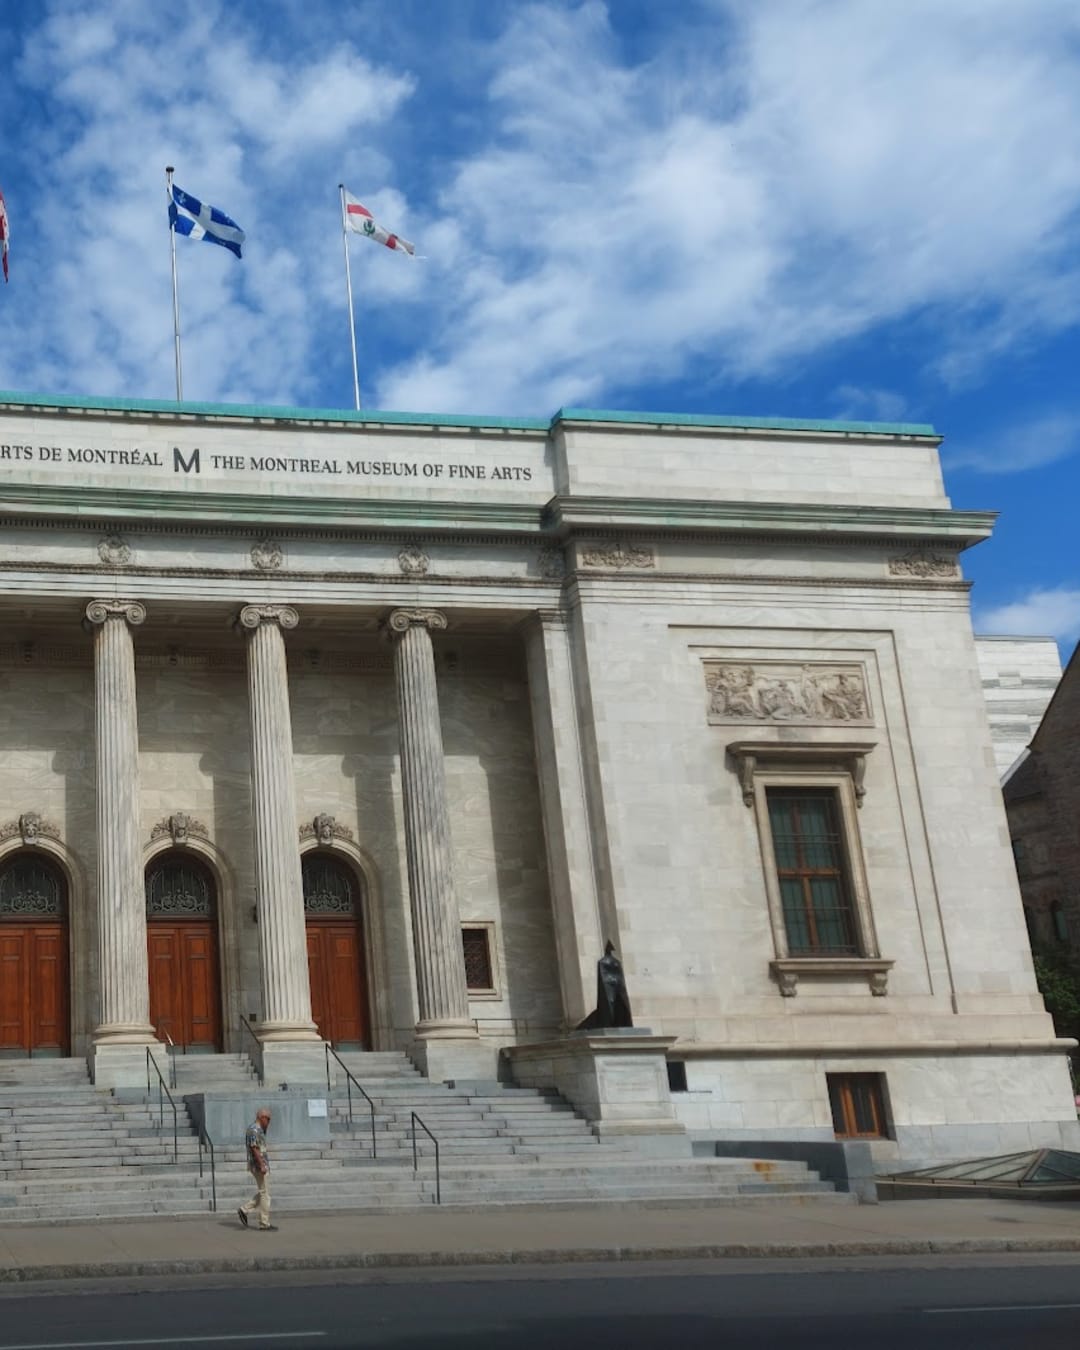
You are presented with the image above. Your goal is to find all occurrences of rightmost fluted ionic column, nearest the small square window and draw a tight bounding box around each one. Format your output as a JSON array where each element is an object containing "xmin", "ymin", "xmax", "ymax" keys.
[{"xmin": 387, "ymin": 609, "xmax": 475, "ymax": 1037}]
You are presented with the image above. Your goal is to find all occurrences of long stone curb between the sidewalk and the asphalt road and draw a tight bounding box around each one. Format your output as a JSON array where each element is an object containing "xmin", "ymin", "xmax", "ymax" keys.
[{"xmin": 0, "ymin": 1237, "xmax": 1080, "ymax": 1284}]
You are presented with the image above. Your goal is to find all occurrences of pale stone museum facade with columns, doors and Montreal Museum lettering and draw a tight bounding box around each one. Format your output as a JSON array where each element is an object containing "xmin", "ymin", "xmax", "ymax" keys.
[{"xmin": 0, "ymin": 396, "xmax": 1076, "ymax": 1165}]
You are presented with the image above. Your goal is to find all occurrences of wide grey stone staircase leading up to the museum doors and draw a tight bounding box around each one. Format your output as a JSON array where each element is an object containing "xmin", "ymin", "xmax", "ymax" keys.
[{"xmin": 0, "ymin": 1053, "xmax": 853, "ymax": 1223}]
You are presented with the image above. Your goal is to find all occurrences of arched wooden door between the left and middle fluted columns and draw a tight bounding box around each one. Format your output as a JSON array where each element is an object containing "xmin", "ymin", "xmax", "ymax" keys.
[{"xmin": 146, "ymin": 853, "xmax": 221, "ymax": 1053}]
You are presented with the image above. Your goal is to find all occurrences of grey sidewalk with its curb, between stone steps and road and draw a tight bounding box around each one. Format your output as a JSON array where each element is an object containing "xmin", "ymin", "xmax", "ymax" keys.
[{"xmin": 0, "ymin": 1200, "xmax": 1080, "ymax": 1283}]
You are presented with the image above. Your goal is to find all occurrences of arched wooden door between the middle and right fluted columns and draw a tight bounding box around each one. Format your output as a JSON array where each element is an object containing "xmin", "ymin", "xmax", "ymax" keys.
[{"xmin": 302, "ymin": 853, "xmax": 369, "ymax": 1050}]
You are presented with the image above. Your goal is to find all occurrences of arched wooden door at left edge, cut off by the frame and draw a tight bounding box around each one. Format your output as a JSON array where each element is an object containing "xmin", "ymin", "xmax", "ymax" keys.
[{"xmin": 0, "ymin": 852, "xmax": 70, "ymax": 1056}]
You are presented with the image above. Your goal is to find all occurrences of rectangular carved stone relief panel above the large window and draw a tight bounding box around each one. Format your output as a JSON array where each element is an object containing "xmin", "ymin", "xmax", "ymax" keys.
[{"xmin": 703, "ymin": 660, "xmax": 873, "ymax": 726}]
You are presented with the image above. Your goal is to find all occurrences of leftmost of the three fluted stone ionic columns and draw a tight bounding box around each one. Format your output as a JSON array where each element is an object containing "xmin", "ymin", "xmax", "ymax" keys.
[{"xmin": 86, "ymin": 599, "xmax": 155, "ymax": 1046}]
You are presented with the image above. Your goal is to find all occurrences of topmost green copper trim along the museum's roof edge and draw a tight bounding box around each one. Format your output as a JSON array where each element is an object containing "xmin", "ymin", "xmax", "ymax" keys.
[{"xmin": 0, "ymin": 390, "xmax": 937, "ymax": 437}]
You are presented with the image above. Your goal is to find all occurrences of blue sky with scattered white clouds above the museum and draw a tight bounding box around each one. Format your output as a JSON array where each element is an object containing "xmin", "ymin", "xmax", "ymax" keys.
[{"xmin": 0, "ymin": 0, "xmax": 1080, "ymax": 651}]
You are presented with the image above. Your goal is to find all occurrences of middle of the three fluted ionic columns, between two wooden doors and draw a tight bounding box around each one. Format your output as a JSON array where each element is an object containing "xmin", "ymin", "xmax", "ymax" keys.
[{"xmin": 239, "ymin": 605, "xmax": 319, "ymax": 1041}]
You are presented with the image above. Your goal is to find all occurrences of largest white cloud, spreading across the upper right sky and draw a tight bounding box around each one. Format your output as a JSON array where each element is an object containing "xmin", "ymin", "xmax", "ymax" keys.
[{"xmin": 379, "ymin": 0, "xmax": 1080, "ymax": 410}]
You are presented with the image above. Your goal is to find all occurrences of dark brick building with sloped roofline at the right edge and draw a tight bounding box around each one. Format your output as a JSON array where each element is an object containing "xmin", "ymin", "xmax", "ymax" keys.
[{"xmin": 1004, "ymin": 645, "xmax": 1080, "ymax": 954}]
